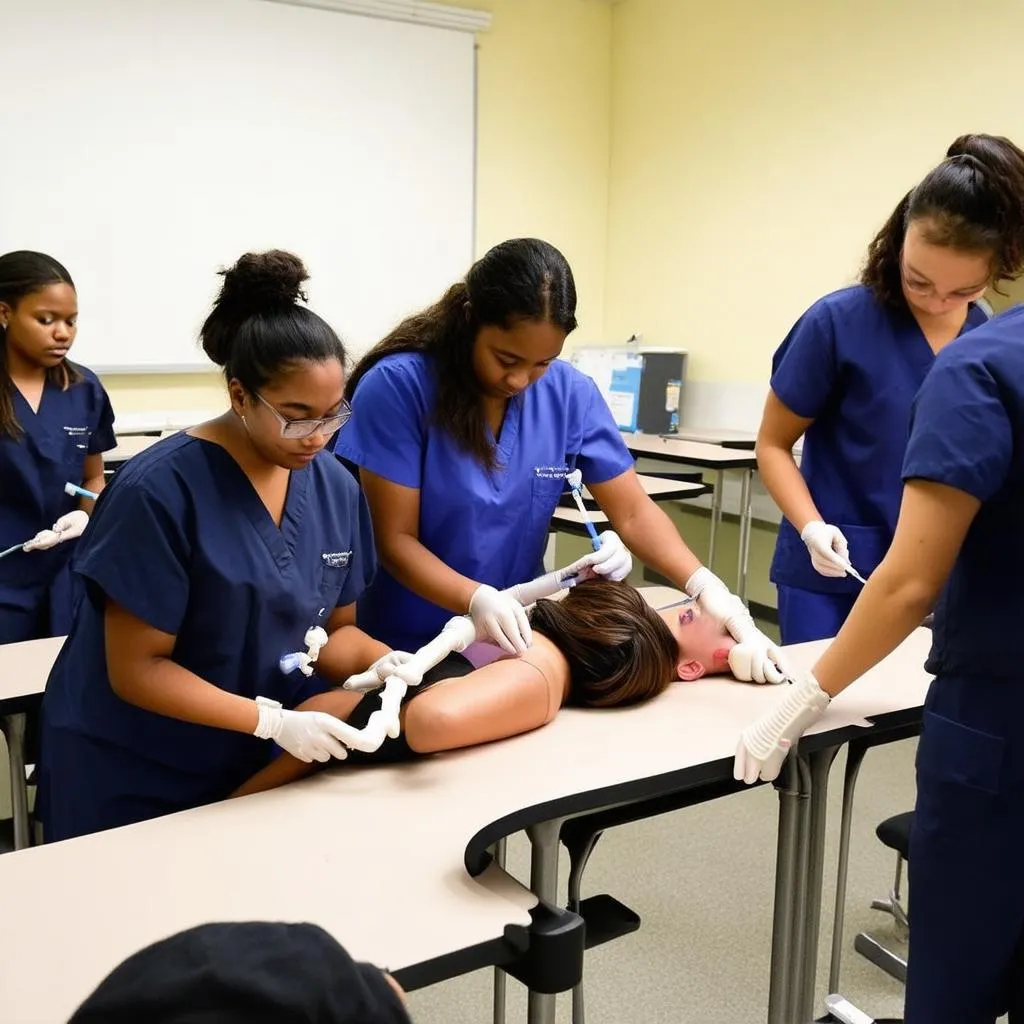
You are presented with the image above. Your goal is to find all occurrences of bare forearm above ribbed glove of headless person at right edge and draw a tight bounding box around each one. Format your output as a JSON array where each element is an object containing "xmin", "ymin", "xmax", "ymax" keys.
[{"xmin": 811, "ymin": 561, "xmax": 936, "ymax": 696}]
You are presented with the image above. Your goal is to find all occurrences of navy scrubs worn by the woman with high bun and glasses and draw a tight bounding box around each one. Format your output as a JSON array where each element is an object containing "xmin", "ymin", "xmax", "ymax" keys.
[{"xmin": 42, "ymin": 433, "xmax": 376, "ymax": 823}]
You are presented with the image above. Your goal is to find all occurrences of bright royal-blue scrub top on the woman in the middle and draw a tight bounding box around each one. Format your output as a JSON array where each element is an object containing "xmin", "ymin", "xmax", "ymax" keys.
[{"xmin": 335, "ymin": 353, "xmax": 633, "ymax": 650}]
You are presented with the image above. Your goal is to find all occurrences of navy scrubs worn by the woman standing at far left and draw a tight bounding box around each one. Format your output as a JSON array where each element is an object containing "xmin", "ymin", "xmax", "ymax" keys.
[{"xmin": 0, "ymin": 365, "xmax": 117, "ymax": 643}]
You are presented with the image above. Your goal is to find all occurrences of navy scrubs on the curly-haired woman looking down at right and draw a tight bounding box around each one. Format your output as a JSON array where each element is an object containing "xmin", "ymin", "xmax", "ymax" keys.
[{"xmin": 770, "ymin": 285, "xmax": 987, "ymax": 594}]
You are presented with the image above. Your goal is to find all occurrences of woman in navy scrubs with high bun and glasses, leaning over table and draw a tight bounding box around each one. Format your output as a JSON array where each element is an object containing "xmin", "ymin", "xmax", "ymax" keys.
[{"xmin": 39, "ymin": 252, "xmax": 418, "ymax": 842}]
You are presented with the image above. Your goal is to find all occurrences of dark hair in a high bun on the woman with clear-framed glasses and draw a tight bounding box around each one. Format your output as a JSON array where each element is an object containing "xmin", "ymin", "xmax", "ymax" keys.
[{"xmin": 200, "ymin": 249, "xmax": 345, "ymax": 394}]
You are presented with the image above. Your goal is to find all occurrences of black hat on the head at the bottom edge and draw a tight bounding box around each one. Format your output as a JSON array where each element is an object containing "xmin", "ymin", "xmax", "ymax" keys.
[{"xmin": 69, "ymin": 922, "xmax": 410, "ymax": 1024}]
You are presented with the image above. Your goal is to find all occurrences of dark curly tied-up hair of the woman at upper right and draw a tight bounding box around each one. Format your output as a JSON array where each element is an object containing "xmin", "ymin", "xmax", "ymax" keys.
[{"xmin": 860, "ymin": 135, "xmax": 1024, "ymax": 309}]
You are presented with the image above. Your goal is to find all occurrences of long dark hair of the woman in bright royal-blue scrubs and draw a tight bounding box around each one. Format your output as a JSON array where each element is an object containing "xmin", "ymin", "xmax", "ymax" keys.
[{"xmin": 345, "ymin": 239, "xmax": 577, "ymax": 469}]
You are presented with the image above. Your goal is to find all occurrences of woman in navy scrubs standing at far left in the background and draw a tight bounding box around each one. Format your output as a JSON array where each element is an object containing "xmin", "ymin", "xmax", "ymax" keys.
[{"xmin": 0, "ymin": 252, "xmax": 115, "ymax": 643}]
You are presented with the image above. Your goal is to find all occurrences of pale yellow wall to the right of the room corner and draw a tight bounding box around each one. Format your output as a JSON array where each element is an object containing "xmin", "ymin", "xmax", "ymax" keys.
[{"xmin": 605, "ymin": 0, "xmax": 1024, "ymax": 381}]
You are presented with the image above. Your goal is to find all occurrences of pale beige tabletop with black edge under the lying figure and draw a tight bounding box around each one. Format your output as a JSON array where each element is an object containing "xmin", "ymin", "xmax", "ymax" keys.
[{"xmin": 0, "ymin": 588, "xmax": 931, "ymax": 1024}]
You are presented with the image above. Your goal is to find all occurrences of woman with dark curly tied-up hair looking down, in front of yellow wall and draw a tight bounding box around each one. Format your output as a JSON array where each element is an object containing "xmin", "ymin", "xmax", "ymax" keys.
[{"xmin": 757, "ymin": 135, "xmax": 1024, "ymax": 644}]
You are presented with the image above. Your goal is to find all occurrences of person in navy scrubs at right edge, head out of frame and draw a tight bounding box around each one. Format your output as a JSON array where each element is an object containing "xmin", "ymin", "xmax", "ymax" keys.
[{"xmin": 735, "ymin": 307, "xmax": 1024, "ymax": 1024}]
